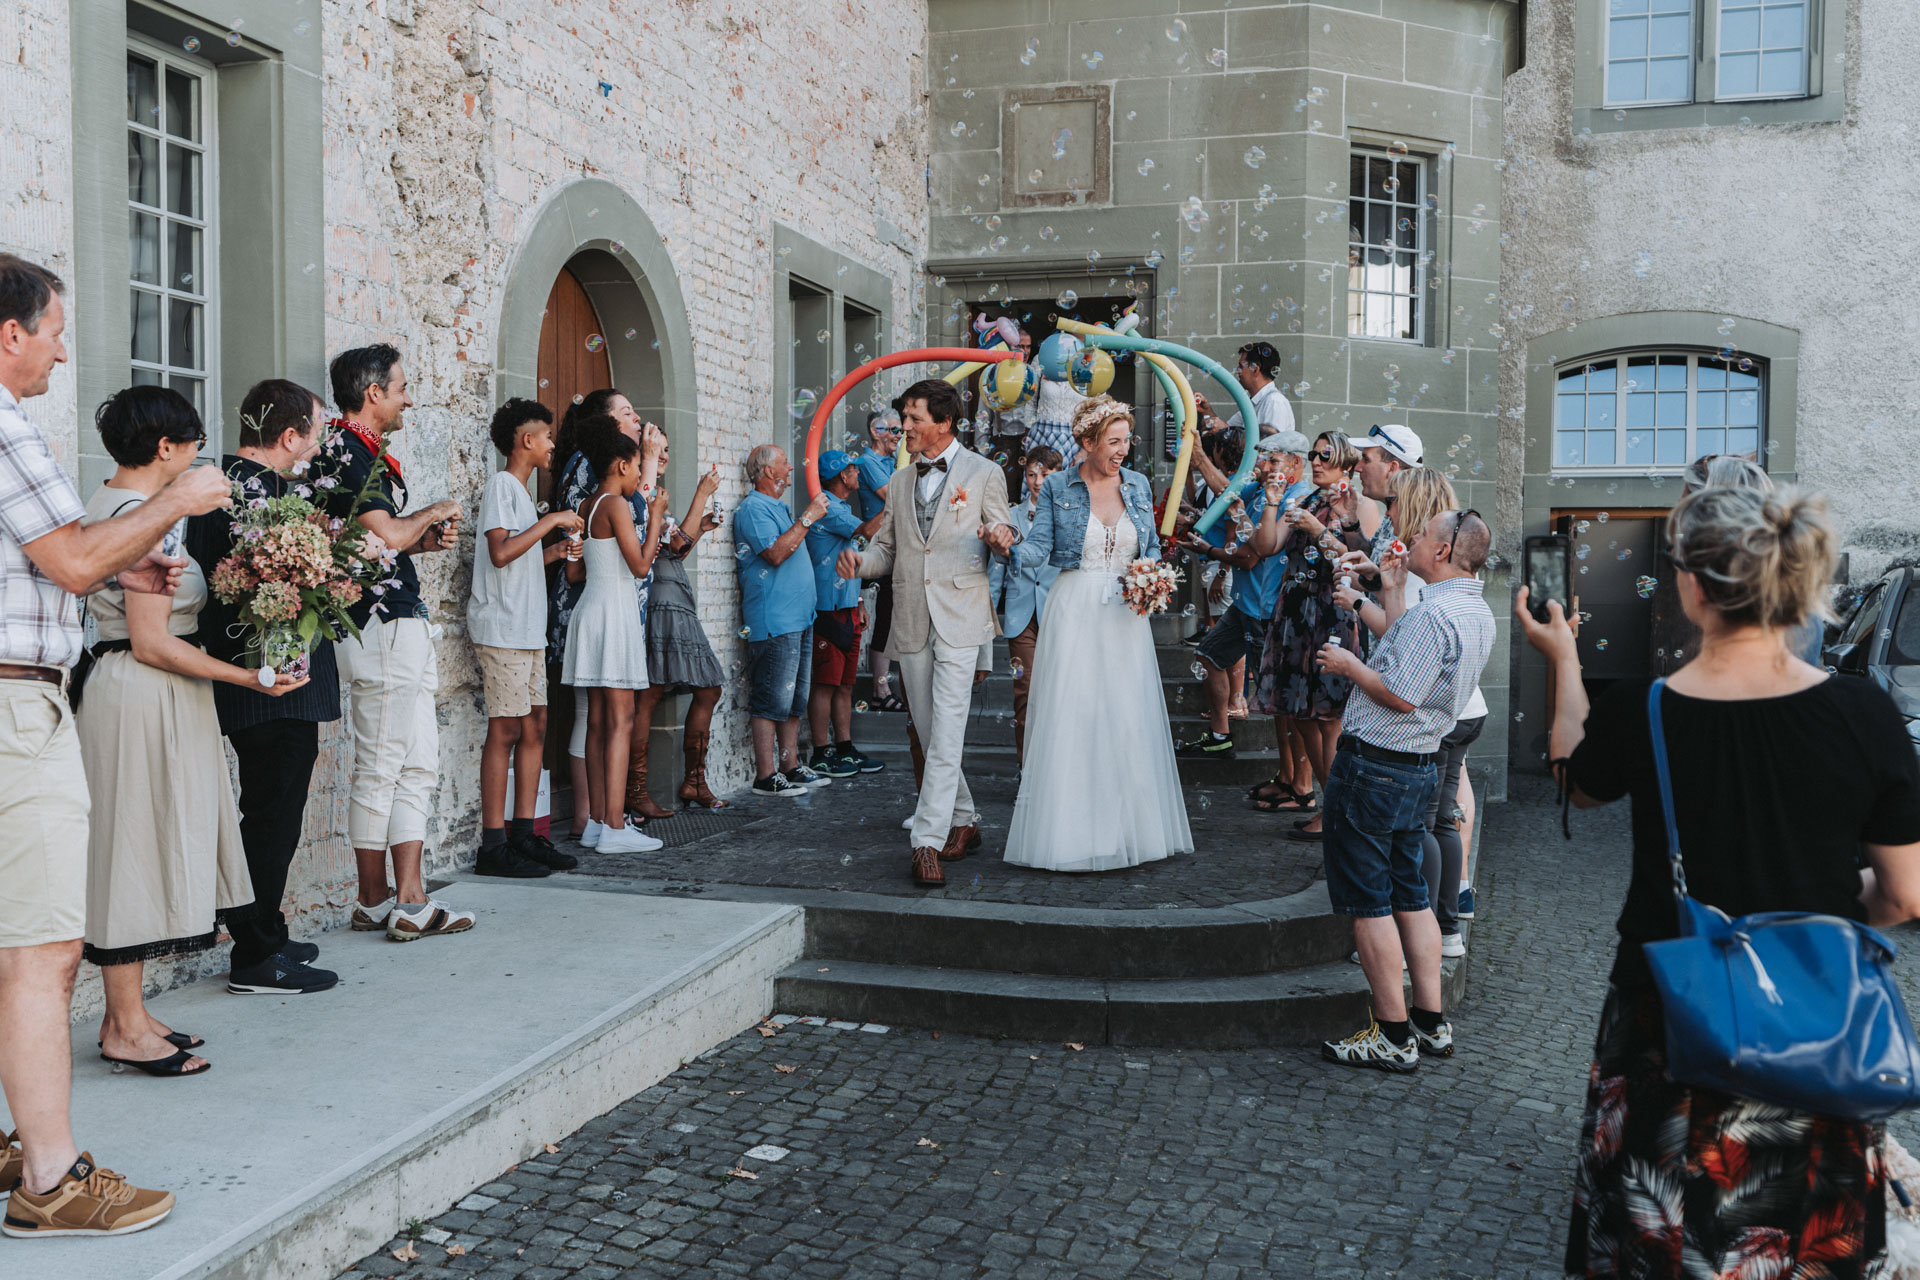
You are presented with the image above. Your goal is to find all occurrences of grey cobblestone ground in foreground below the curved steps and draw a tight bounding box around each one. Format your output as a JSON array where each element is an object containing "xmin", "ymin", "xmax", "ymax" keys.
[{"xmin": 349, "ymin": 779, "xmax": 1914, "ymax": 1280}]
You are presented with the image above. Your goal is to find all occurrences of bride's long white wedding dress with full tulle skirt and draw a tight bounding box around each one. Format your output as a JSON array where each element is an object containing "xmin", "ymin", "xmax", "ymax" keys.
[{"xmin": 1006, "ymin": 516, "xmax": 1194, "ymax": 871}]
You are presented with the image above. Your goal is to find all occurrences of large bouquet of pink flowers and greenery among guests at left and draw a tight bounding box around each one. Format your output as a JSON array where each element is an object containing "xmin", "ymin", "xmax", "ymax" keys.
[{"xmin": 209, "ymin": 435, "xmax": 399, "ymax": 689}]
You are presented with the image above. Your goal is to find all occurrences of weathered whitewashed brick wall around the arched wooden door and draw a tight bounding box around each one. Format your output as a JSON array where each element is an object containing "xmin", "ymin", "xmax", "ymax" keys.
[{"xmin": 0, "ymin": 0, "xmax": 925, "ymax": 1013}]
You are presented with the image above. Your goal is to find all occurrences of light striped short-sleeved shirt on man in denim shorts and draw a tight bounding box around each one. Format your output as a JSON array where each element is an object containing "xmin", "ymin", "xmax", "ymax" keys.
[{"xmin": 1340, "ymin": 578, "xmax": 1494, "ymax": 756}]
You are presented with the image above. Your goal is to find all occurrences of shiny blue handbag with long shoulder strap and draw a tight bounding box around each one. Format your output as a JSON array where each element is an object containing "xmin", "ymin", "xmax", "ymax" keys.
[{"xmin": 1644, "ymin": 679, "xmax": 1920, "ymax": 1121}]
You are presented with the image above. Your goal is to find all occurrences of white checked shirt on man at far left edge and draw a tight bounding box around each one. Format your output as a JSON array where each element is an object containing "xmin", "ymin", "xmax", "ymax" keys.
[{"xmin": 0, "ymin": 386, "xmax": 86, "ymax": 666}]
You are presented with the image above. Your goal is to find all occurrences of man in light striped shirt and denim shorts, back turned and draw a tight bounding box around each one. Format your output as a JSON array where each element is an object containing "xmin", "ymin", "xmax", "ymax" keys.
[{"xmin": 1317, "ymin": 510, "xmax": 1494, "ymax": 1071}]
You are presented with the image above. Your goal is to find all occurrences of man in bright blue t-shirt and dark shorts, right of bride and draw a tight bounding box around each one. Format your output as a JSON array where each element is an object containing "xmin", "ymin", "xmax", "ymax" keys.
[{"xmin": 1175, "ymin": 430, "xmax": 1311, "ymax": 773}]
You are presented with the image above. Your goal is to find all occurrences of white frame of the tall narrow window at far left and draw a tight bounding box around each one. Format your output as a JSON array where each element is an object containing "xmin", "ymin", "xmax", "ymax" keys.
[{"xmin": 125, "ymin": 35, "xmax": 223, "ymax": 441}]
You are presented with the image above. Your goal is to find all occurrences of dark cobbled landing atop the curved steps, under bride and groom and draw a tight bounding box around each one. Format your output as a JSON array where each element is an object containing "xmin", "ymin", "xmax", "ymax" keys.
[{"xmin": 553, "ymin": 768, "xmax": 1321, "ymax": 910}]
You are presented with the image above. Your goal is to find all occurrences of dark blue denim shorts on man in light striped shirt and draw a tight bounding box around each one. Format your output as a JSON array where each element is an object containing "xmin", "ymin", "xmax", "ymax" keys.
[{"xmin": 1323, "ymin": 750, "xmax": 1438, "ymax": 915}]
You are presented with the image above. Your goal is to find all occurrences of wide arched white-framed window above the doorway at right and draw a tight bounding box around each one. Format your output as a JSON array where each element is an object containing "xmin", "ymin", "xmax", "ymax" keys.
[{"xmin": 1553, "ymin": 351, "xmax": 1766, "ymax": 472}]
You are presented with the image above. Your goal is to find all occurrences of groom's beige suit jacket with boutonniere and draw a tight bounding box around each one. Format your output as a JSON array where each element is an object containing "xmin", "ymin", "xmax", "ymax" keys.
[{"xmin": 860, "ymin": 447, "xmax": 1012, "ymax": 654}]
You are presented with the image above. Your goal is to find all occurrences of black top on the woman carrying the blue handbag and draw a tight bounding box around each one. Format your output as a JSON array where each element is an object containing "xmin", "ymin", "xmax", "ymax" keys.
[{"xmin": 1569, "ymin": 676, "xmax": 1920, "ymax": 986}]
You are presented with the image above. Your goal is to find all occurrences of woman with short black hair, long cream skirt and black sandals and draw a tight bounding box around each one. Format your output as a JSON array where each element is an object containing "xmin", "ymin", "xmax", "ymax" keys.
[{"xmin": 77, "ymin": 386, "xmax": 312, "ymax": 1077}]
